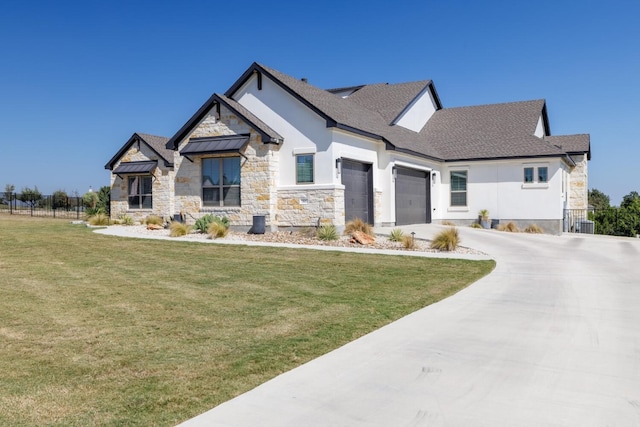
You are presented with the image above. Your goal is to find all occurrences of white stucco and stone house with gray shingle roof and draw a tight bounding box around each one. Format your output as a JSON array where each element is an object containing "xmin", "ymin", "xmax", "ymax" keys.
[{"xmin": 105, "ymin": 63, "xmax": 591, "ymax": 233}]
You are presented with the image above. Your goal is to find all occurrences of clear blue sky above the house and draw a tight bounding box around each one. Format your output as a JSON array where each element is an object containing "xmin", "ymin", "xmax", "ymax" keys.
[{"xmin": 0, "ymin": 0, "xmax": 640, "ymax": 204}]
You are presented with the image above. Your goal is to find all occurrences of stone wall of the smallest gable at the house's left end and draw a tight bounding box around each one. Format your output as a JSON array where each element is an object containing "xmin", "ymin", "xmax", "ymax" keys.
[{"xmin": 111, "ymin": 142, "xmax": 173, "ymax": 221}]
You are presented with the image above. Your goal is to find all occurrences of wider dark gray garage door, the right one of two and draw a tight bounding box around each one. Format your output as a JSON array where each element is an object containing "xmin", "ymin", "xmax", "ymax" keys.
[{"xmin": 396, "ymin": 167, "xmax": 431, "ymax": 225}]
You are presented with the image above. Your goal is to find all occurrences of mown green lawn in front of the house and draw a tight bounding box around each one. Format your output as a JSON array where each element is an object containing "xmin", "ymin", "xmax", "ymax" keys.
[{"xmin": 0, "ymin": 215, "xmax": 494, "ymax": 426}]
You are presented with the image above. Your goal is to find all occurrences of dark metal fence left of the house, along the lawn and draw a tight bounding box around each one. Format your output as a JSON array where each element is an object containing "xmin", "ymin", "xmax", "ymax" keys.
[{"xmin": 0, "ymin": 193, "xmax": 85, "ymax": 219}]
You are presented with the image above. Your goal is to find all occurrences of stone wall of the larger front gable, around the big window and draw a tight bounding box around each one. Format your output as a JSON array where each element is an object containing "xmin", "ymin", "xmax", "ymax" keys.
[{"xmin": 174, "ymin": 108, "xmax": 280, "ymax": 229}]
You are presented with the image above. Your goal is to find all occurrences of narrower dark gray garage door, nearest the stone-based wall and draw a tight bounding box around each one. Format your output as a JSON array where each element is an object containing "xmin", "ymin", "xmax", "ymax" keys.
[{"xmin": 342, "ymin": 159, "xmax": 373, "ymax": 224}]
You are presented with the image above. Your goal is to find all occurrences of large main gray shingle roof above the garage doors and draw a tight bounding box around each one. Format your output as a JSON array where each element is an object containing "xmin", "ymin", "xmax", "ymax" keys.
[{"xmin": 230, "ymin": 63, "xmax": 584, "ymax": 161}]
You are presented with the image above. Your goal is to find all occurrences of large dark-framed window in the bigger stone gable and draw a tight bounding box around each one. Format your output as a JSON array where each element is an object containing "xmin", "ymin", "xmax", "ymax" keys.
[{"xmin": 202, "ymin": 157, "xmax": 240, "ymax": 206}]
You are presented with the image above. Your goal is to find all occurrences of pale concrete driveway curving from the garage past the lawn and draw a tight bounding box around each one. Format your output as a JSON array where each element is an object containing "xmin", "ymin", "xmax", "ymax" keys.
[{"xmin": 183, "ymin": 225, "xmax": 640, "ymax": 427}]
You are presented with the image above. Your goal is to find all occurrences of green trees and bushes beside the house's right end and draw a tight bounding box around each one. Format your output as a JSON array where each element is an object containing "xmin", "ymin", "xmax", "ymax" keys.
[{"xmin": 589, "ymin": 189, "xmax": 640, "ymax": 237}]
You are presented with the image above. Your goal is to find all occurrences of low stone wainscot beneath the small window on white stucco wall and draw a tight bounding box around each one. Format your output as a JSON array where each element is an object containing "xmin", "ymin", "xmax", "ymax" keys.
[{"xmin": 276, "ymin": 186, "xmax": 344, "ymax": 228}]
